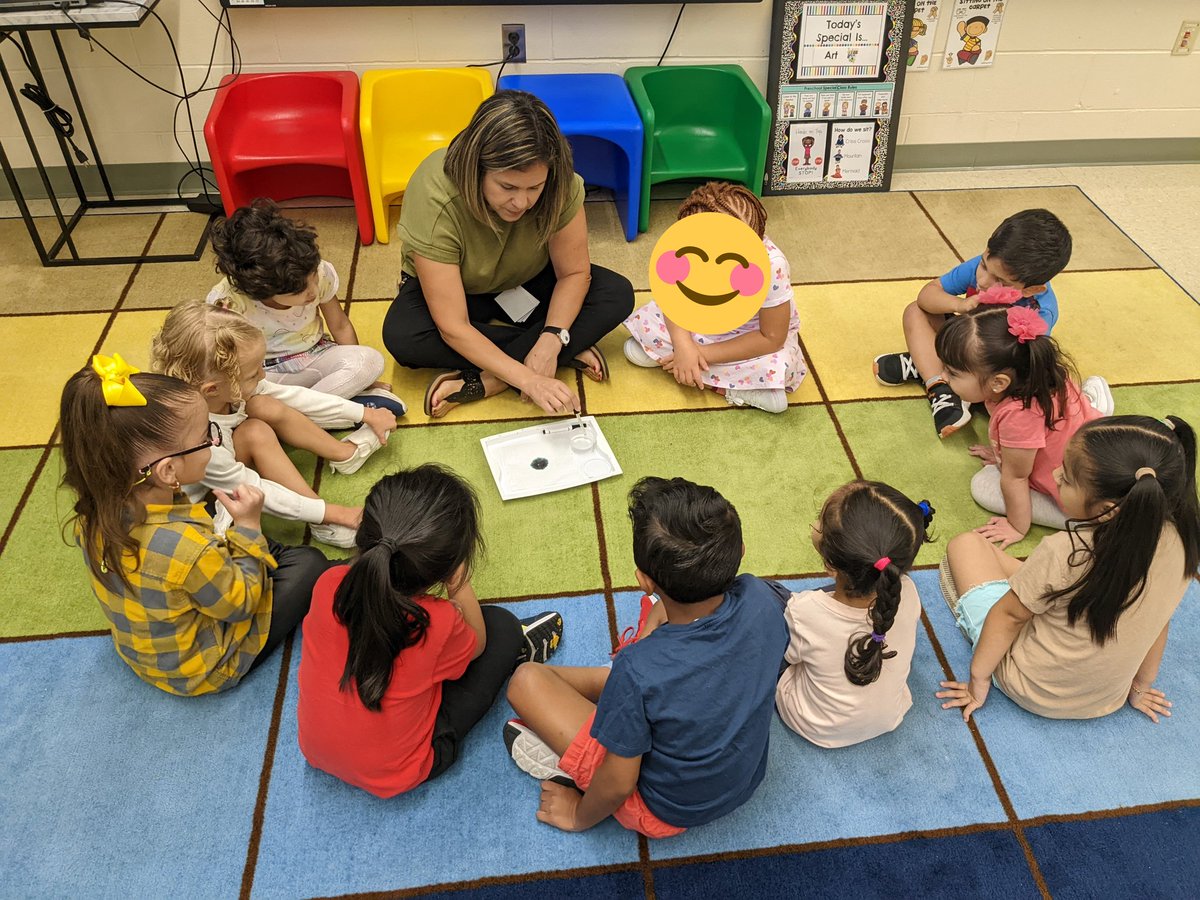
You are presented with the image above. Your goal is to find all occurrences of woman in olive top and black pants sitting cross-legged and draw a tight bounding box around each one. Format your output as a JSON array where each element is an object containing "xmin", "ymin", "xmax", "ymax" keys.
[{"xmin": 383, "ymin": 90, "xmax": 634, "ymax": 418}]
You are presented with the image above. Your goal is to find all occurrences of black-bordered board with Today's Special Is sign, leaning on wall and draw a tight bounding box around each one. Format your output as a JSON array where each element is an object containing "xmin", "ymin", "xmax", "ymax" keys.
[{"xmin": 764, "ymin": 0, "xmax": 912, "ymax": 194}]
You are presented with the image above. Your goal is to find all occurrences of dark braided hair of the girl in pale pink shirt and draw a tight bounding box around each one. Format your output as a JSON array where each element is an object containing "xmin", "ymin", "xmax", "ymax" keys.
[{"xmin": 817, "ymin": 481, "xmax": 934, "ymax": 686}]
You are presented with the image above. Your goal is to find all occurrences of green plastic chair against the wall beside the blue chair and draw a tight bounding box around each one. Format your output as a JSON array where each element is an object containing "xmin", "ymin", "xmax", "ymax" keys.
[{"xmin": 625, "ymin": 66, "xmax": 770, "ymax": 232}]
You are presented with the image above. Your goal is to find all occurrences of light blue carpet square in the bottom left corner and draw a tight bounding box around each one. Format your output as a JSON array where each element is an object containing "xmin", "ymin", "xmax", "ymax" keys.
[{"xmin": 0, "ymin": 635, "xmax": 280, "ymax": 898}]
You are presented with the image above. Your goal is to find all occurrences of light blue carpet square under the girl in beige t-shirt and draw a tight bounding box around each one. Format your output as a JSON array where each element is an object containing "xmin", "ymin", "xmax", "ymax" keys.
[{"xmin": 917, "ymin": 571, "xmax": 1200, "ymax": 818}]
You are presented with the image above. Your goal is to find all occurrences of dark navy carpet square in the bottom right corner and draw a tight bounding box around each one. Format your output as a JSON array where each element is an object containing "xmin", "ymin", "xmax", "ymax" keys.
[{"xmin": 1025, "ymin": 806, "xmax": 1200, "ymax": 900}]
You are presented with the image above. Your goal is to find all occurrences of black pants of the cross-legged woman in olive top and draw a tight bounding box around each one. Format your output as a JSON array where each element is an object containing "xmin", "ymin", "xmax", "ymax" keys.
[{"xmin": 383, "ymin": 264, "xmax": 634, "ymax": 370}]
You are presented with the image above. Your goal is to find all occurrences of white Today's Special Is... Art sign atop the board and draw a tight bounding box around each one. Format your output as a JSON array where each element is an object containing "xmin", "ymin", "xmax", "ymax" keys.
[{"xmin": 796, "ymin": 2, "xmax": 888, "ymax": 82}]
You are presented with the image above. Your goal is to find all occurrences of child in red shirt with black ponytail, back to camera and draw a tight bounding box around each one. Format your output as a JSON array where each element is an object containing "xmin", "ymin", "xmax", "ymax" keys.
[{"xmin": 296, "ymin": 464, "xmax": 563, "ymax": 797}]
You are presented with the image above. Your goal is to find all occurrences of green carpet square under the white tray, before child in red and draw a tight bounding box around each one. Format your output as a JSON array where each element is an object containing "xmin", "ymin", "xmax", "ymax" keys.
[{"xmin": 320, "ymin": 422, "xmax": 604, "ymax": 600}]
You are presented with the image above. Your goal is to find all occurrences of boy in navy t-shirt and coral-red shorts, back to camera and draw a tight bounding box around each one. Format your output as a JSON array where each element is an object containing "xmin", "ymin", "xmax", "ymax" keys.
[{"xmin": 504, "ymin": 478, "xmax": 788, "ymax": 838}]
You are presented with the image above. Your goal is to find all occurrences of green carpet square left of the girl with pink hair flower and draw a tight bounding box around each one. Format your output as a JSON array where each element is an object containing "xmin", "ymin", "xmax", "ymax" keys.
[{"xmin": 834, "ymin": 397, "xmax": 1050, "ymax": 564}]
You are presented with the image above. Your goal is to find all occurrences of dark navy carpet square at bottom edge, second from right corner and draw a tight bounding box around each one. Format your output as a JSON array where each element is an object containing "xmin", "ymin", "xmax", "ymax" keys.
[{"xmin": 654, "ymin": 829, "xmax": 1040, "ymax": 900}]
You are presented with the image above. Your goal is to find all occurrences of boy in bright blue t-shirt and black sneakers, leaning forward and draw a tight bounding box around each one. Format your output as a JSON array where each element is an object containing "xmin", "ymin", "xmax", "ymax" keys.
[{"xmin": 875, "ymin": 209, "xmax": 1070, "ymax": 438}]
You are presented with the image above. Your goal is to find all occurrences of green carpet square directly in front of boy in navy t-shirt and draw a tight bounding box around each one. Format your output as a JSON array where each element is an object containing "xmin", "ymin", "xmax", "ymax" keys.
[{"xmin": 600, "ymin": 407, "xmax": 854, "ymax": 587}]
